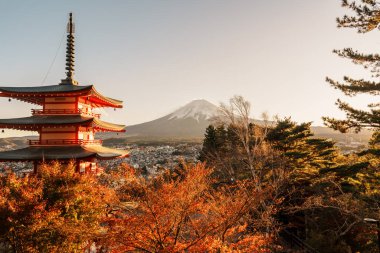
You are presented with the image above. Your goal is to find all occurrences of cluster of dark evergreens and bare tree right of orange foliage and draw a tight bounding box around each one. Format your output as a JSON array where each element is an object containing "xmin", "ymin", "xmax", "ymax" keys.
[{"xmin": 202, "ymin": 94, "xmax": 379, "ymax": 252}]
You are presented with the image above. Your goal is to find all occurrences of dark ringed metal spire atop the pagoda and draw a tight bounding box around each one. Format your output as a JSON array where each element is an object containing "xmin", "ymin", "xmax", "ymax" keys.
[{"xmin": 61, "ymin": 12, "xmax": 78, "ymax": 85}]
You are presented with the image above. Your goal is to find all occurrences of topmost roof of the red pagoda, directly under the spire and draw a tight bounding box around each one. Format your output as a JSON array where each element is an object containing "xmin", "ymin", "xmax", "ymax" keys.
[{"xmin": 0, "ymin": 84, "xmax": 123, "ymax": 108}]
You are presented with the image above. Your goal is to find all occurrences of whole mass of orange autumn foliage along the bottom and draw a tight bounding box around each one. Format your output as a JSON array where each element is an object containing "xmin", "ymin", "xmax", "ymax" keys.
[{"xmin": 0, "ymin": 164, "xmax": 280, "ymax": 253}]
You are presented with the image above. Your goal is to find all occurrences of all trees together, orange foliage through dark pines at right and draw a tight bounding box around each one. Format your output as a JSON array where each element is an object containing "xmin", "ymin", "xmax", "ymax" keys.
[{"xmin": 0, "ymin": 0, "xmax": 380, "ymax": 253}]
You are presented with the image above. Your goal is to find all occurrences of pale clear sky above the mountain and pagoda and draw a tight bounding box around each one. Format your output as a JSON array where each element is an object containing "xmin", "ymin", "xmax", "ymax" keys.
[{"xmin": 0, "ymin": 0, "xmax": 380, "ymax": 135}]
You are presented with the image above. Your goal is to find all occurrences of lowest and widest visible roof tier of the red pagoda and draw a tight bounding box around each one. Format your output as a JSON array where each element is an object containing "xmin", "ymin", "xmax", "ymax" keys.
[{"xmin": 0, "ymin": 145, "xmax": 128, "ymax": 162}]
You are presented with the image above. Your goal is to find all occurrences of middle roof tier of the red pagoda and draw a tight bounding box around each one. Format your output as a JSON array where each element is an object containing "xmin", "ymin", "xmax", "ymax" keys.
[{"xmin": 0, "ymin": 115, "xmax": 125, "ymax": 132}]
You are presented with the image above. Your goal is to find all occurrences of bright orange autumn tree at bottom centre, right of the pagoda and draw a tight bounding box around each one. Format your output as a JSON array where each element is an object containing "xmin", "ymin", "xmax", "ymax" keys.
[{"xmin": 106, "ymin": 164, "xmax": 273, "ymax": 252}]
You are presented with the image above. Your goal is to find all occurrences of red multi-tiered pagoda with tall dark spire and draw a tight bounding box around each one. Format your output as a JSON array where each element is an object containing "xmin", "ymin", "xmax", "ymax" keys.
[{"xmin": 0, "ymin": 13, "xmax": 128, "ymax": 173}]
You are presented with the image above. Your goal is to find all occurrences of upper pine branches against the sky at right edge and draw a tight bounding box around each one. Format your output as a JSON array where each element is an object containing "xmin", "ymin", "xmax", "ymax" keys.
[{"xmin": 323, "ymin": 0, "xmax": 380, "ymax": 145}]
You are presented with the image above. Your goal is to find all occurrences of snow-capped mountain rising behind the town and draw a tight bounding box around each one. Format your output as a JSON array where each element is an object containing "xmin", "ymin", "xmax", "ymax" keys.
[{"xmin": 126, "ymin": 99, "xmax": 218, "ymax": 137}]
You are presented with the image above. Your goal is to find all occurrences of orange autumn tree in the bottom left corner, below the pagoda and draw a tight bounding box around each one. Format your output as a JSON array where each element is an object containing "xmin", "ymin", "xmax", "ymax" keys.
[{"xmin": 0, "ymin": 163, "xmax": 115, "ymax": 252}]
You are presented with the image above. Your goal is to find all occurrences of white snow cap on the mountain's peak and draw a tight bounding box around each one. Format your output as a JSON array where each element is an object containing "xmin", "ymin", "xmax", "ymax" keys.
[{"xmin": 169, "ymin": 99, "xmax": 218, "ymax": 122}]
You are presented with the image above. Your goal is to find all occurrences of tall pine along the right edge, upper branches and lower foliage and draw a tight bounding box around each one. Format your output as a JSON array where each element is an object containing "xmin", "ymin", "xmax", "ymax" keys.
[{"xmin": 323, "ymin": 3, "xmax": 380, "ymax": 250}]
